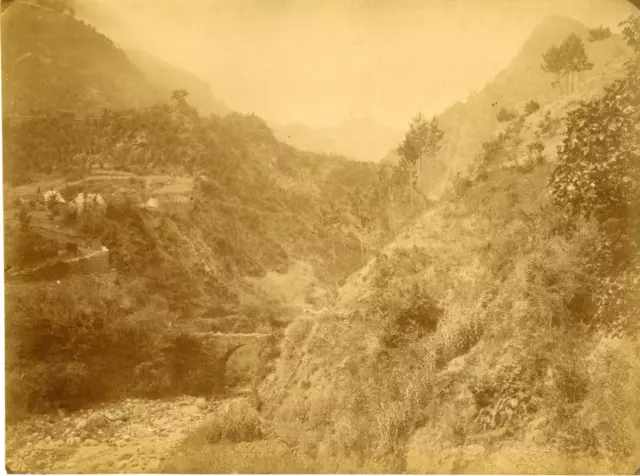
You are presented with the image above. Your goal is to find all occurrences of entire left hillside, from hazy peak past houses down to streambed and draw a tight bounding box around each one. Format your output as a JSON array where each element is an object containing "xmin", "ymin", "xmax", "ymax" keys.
[{"xmin": 2, "ymin": 0, "xmax": 410, "ymax": 420}]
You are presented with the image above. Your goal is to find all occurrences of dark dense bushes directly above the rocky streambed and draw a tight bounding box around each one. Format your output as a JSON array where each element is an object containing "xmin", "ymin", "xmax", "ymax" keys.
[{"xmin": 6, "ymin": 278, "xmax": 224, "ymax": 418}]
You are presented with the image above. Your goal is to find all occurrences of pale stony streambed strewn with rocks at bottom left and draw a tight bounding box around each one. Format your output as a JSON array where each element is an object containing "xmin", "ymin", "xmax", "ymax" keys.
[{"xmin": 6, "ymin": 397, "xmax": 245, "ymax": 473}]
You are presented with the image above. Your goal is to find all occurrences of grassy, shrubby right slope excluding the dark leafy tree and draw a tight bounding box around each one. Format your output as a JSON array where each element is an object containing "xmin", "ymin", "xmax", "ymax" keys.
[{"xmin": 251, "ymin": 48, "xmax": 640, "ymax": 473}]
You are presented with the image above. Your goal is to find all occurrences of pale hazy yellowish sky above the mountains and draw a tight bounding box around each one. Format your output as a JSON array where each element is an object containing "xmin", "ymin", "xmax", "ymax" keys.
[{"xmin": 84, "ymin": 0, "xmax": 633, "ymax": 127}]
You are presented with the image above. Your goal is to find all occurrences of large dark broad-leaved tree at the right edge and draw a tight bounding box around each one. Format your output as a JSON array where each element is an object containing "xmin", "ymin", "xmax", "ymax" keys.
[{"xmin": 551, "ymin": 59, "xmax": 640, "ymax": 260}]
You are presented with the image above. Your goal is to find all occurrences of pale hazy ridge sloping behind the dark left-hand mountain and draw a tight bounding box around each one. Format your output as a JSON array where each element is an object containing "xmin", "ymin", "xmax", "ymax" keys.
[{"xmin": 125, "ymin": 49, "xmax": 231, "ymax": 116}]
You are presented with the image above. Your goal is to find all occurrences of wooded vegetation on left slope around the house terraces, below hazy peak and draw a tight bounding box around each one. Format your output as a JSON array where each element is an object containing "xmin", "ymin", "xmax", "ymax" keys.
[{"xmin": 3, "ymin": 83, "xmax": 424, "ymax": 414}]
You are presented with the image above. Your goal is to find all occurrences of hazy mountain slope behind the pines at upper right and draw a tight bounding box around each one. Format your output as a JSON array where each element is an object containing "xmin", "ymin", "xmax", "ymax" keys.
[{"xmin": 404, "ymin": 16, "xmax": 629, "ymax": 194}]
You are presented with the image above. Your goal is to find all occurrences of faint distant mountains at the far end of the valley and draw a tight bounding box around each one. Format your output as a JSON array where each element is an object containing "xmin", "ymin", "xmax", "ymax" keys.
[{"xmin": 272, "ymin": 118, "xmax": 403, "ymax": 162}]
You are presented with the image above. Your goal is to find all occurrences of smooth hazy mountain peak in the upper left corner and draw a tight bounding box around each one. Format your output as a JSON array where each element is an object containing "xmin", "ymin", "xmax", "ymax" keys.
[{"xmin": 1, "ymin": 1, "xmax": 165, "ymax": 116}]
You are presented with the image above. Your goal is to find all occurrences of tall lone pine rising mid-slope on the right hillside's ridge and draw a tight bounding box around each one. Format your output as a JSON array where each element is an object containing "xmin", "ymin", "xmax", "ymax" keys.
[{"xmin": 398, "ymin": 114, "xmax": 444, "ymax": 206}]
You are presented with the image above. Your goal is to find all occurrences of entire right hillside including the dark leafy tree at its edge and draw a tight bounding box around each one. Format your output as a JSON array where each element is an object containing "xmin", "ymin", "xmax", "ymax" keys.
[{"xmin": 249, "ymin": 27, "xmax": 640, "ymax": 474}]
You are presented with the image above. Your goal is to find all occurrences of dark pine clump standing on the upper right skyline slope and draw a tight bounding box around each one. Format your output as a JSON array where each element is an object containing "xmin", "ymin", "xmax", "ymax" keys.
[{"xmin": 542, "ymin": 33, "xmax": 593, "ymax": 93}]
